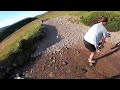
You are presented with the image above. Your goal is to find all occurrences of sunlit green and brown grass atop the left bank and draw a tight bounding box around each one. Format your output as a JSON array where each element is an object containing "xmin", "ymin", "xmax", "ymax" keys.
[{"xmin": 0, "ymin": 21, "xmax": 41, "ymax": 60}]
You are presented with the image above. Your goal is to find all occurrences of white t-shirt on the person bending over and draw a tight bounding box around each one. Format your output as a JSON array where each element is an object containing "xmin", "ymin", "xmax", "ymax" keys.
[{"xmin": 84, "ymin": 22, "xmax": 108, "ymax": 48}]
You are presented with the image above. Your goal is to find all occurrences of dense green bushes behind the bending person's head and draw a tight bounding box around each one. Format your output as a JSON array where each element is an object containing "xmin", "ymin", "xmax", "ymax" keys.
[{"xmin": 82, "ymin": 11, "xmax": 120, "ymax": 32}]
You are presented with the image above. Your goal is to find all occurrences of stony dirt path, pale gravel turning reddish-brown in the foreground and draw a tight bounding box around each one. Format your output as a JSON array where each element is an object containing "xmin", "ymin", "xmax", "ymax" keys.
[{"xmin": 19, "ymin": 16, "xmax": 120, "ymax": 79}]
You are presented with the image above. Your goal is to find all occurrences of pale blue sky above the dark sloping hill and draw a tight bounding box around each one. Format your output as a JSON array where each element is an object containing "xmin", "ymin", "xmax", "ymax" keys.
[{"xmin": 0, "ymin": 11, "xmax": 47, "ymax": 28}]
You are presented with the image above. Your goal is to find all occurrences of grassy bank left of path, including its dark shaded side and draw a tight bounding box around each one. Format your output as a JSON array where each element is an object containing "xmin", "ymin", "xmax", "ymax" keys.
[{"xmin": 0, "ymin": 20, "xmax": 43, "ymax": 79}]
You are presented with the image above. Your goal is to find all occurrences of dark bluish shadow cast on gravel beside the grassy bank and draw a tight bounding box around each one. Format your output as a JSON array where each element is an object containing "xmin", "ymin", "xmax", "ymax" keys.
[{"xmin": 33, "ymin": 24, "xmax": 62, "ymax": 53}]
